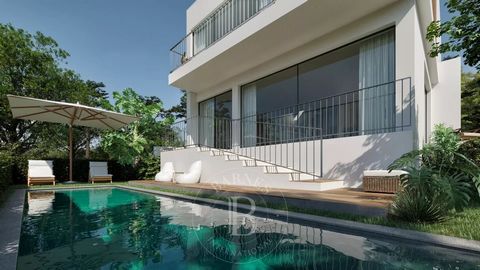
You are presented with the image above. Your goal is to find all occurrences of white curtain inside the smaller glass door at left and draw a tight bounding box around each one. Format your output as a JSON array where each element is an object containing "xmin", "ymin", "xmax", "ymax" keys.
[{"xmin": 199, "ymin": 99, "xmax": 215, "ymax": 147}]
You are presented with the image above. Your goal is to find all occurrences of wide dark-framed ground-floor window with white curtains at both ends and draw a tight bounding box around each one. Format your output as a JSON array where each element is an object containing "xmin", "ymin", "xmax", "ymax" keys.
[{"xmin": 242, "ymin": 29, "xmax": 395, "ymax": 146}]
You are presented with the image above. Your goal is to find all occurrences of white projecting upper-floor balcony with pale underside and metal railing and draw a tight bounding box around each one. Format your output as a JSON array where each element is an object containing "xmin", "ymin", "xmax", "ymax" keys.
[{"xmin": 168, "ymin": 0, "xmax": 402, "ymax": 90}]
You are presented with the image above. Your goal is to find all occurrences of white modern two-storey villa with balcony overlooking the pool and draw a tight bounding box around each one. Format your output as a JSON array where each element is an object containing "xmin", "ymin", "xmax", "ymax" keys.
[{"xmin": 161, "ymin": 0, "xmax": 461, "ymax": 191}]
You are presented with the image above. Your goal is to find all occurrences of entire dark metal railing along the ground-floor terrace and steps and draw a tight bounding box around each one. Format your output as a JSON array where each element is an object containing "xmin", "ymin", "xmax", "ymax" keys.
[{"xmin": 163, "ymin": 78, "xmax": 413, "ymax": 178}]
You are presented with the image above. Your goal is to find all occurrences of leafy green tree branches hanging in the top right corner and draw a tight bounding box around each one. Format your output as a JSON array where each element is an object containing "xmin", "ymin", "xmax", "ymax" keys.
[{"xmin": 427, "ymin": 0, "xmax": 480, "ymax": 70}]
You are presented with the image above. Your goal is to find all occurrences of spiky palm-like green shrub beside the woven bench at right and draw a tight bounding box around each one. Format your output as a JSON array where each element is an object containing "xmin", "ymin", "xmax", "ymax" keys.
[{"xmin": 389, "ymin": 125, "xmax": 480, "ymax": 222}]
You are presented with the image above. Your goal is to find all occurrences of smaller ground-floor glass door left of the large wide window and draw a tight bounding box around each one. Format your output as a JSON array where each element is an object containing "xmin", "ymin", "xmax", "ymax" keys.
[{"xmin": 198, "ymin": 91, "xmax": 232, "ymax": 149}]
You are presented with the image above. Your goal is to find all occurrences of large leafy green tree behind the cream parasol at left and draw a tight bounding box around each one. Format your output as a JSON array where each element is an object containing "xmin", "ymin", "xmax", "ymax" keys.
[{"xmin": 0, "ymin": 24, "xmax": 106, "ymax": 157}]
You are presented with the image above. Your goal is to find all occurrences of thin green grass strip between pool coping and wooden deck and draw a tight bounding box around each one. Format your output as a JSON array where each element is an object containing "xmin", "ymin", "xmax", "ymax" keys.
[{"xmin": 24, "ymin": 182, "xmax": 480, "ymax": 241}]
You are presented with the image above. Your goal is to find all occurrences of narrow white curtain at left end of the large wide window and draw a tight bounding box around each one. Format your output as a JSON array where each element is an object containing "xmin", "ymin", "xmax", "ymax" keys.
[{"xmin": 242, "ymin": 84, "xmax": 257, "ymax": 147}]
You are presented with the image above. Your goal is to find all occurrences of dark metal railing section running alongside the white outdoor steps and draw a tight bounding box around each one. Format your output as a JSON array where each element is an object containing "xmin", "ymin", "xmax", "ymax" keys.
[{"xmin": 185, "ymin": 116, "xmax": 323, "ymax": 180}]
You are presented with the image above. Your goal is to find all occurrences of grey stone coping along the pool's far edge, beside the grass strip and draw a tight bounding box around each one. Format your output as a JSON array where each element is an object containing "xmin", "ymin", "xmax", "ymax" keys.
[{"xmin": 26, "ymin": 184, "xmax": 480, "ymax": 253}]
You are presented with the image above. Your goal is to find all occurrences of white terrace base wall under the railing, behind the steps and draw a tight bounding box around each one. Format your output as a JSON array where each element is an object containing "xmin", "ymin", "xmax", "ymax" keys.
[{"xmin": 236, "ymin": 130, "xmax": 413, "ymax": 187}]
